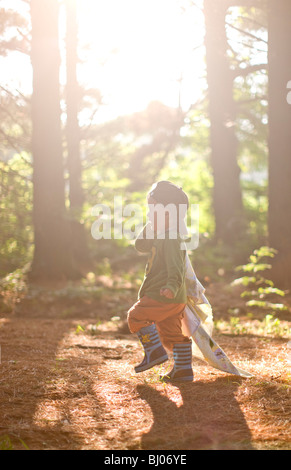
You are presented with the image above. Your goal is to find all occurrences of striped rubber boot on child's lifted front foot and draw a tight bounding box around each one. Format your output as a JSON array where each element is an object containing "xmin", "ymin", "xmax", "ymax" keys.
[{"xmin": 134, "ymin": 323, "xmax": 168, "ymax": 373}]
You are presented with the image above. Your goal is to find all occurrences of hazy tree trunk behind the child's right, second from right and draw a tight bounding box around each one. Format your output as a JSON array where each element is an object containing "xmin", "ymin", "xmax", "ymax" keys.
[{"xmin": 204, "ymin": 0, "xmax": 243, "ymax": 243}]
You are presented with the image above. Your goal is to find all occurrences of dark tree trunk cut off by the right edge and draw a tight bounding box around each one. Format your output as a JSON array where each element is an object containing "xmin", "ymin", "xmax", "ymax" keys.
[{"xmin": 268, "ymin": 0, "xmax": 291, "ymax": 288}]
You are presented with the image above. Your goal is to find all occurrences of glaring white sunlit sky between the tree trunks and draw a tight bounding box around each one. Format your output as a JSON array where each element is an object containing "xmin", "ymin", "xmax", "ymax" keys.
[{"xmin": 78, "ymin": 0, "xmax": 204, "ymax": 123}]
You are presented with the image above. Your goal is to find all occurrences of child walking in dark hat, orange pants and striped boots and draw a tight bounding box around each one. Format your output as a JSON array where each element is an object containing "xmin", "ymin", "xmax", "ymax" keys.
[{"xmin": 127, "ymin": 181, "xmax": 193, "ymax": 381}]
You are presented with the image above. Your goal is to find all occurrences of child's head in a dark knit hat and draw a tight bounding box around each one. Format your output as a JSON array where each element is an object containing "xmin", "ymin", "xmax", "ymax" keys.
[{"xmin": 147, "ymin": 181, "xmax": 189, "ymax": 235}]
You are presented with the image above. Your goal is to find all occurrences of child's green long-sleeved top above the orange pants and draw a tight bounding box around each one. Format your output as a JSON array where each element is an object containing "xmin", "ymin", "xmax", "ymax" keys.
[{"xmin": 135, "ymin": 226, "xmax": 187, "ymax": 303}]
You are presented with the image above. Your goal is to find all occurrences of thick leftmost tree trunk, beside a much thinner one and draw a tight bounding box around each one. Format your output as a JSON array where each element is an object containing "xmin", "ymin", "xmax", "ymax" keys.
[{"xmin": 31, "ymin": 0, "xmax": 76, "ymax": 280}]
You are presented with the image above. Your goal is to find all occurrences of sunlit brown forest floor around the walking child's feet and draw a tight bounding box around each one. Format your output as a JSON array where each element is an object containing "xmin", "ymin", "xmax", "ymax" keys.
[{"xmin": 0, "ymin": 283, "xmax": 291, "ymax": 450}]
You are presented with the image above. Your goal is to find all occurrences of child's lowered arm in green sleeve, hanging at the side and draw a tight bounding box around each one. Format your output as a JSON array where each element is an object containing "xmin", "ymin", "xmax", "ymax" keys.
[{"xmin": 160, "ymin": 239, "xmax": 185, "ymax": 299}]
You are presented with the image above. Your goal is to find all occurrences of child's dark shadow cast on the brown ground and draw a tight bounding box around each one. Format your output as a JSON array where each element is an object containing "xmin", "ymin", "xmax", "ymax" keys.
[{"xmin": 137, "ymin": 376, "xmax": 252, "ymax": 450}]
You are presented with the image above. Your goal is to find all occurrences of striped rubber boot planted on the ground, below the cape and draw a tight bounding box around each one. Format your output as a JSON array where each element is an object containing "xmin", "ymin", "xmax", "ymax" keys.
[{"xmin": 161, "ymin": 343, "xmax": 194, "ymax": 382}]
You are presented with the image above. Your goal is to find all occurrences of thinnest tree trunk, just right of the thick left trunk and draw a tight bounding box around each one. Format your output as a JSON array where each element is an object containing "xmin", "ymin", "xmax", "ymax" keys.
[{"xmin": 65, "ymin": 0, "xmax": 90, "ymax": 271}]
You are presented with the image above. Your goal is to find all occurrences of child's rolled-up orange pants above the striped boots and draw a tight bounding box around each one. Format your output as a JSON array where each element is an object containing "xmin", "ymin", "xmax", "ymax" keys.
[{"xmin": 127, "ymin": 295, "xmax": 191, "ymax": 351}]
